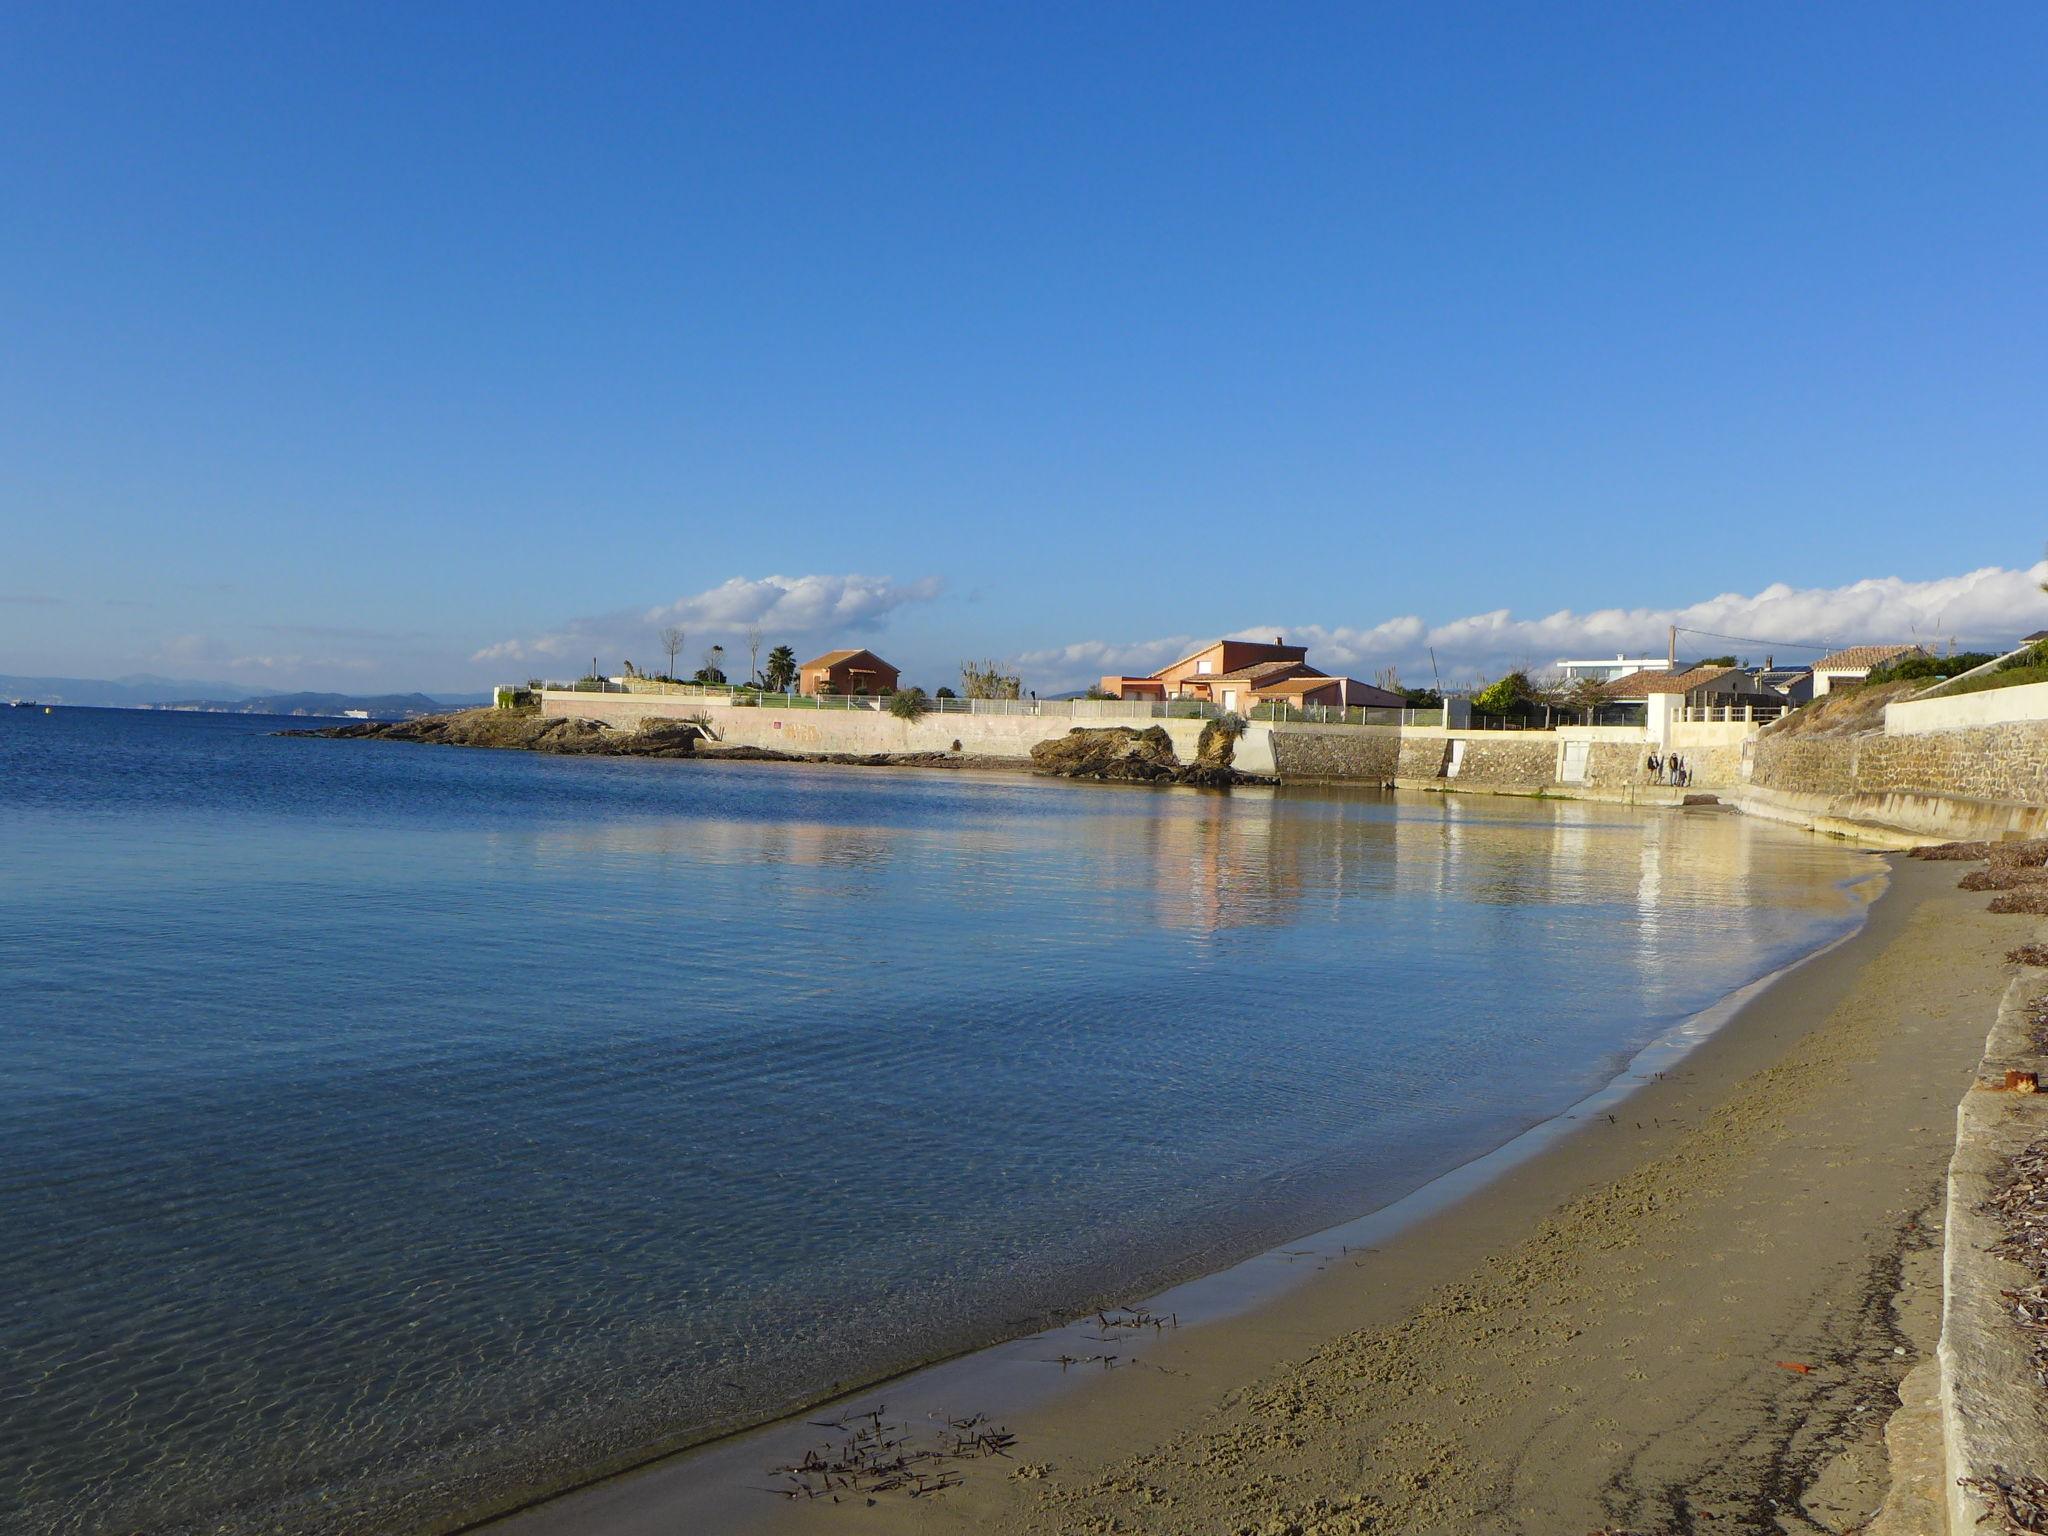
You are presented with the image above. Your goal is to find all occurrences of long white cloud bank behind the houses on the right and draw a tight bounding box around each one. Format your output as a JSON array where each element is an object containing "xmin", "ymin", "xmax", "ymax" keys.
[{"xmin": 1020, "ymin": 561, "xmax": 2048, "ymax": 692}]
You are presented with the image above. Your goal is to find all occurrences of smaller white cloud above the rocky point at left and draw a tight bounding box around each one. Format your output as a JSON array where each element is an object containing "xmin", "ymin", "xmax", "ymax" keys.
[{"xmin": 469, "ymin": 575, "xmax": 940, "ymax": 664}]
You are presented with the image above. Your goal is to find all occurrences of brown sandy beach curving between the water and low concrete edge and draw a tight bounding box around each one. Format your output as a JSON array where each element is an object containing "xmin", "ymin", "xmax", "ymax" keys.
[{"xmin": 483, "ymin": 858, "xmax": 2034, "ymax": 1536}]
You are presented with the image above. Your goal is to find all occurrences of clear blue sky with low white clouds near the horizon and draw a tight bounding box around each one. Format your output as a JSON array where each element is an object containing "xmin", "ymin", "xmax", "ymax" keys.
[{"xmin": 0, "ymin": 2, "xmax": 2048, "ymax": 692}]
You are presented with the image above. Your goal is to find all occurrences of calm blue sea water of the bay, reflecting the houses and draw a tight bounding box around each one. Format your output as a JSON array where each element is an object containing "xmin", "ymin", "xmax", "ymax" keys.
[{"xmin": 0, "ymin": 711, "xmax": 1870, "ymax": 1534}]
